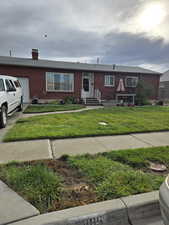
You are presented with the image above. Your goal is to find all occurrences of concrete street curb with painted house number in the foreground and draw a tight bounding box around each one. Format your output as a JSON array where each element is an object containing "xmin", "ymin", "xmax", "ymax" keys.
[{"xmin": 8, "ymin": 191, "xmax": 162, "ymax": 225}]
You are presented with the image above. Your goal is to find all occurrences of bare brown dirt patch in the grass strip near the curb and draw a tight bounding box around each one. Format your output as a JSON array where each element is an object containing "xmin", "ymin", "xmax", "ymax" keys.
[{"xmin": 43, "ymin": 159, "xmax": 97, "ymax": 211}]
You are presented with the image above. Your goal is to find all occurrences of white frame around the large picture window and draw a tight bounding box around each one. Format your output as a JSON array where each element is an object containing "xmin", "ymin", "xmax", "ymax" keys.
[{"xmin": 45, "ymin": 72, "xmax": 75, "ymax": 93}]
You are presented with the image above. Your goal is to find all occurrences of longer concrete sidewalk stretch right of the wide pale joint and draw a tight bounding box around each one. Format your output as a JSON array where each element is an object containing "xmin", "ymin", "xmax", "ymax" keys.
[{"xmin": 51, "ymin": 132, "xmax": 169, "ymax": 158}]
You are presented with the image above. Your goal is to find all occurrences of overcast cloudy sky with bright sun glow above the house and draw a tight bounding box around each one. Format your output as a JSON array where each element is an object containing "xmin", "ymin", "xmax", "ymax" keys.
[{"xmin": 0, "ymin": 0, "xmax": 169, "ymax": 72}]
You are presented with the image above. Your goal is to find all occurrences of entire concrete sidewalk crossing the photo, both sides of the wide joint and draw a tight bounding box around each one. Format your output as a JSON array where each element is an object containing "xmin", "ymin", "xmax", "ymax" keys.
[{"xmin": 0, "ymin": 131, "xmax": 169, "ymax": 163}]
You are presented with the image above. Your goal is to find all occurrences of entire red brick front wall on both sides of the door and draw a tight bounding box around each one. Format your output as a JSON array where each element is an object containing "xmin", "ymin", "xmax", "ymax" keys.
[{"xmin": 0, "ymin": 66, "xmax": 160, "ymax": 99}]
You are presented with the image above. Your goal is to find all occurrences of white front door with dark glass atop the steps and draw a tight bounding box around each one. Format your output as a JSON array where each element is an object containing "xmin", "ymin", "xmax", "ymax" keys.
[{"xmin": 82, "ymin": 72, "xmax": 94, "ymax": 98}]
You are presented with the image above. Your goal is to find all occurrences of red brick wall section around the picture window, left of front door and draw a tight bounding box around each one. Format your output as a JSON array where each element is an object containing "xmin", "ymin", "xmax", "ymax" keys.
[{"xmin": 0, "ymin": 66, "xmax": 82, "ymax": 99}]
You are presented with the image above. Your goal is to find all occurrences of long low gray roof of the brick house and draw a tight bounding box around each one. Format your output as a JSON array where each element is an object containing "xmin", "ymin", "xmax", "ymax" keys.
[{"xmin": 0, "ymin": 56, "xmax": 160, "ymax": 74}]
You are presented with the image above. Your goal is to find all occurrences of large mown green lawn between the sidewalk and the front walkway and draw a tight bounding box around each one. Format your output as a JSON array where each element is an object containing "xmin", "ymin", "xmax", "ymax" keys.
[{"xmin": 4, "ymin": 106, "xmax": 169, "ymax": 141}]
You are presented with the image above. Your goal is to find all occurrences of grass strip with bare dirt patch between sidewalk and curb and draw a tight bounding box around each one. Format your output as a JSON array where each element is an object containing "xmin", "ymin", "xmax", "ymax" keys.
[{"xmin": 0, "ymin": 147, "xmax": 169, "ymax": 213}]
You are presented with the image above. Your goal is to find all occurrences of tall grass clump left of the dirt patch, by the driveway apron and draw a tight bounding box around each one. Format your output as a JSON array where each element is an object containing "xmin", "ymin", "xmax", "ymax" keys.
[{"xmin": 0, "ymin": 163, "xmax": 61, "ymax": 213}]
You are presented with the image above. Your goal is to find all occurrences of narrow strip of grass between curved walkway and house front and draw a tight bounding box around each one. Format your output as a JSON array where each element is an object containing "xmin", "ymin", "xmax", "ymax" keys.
[{"xmin": 24, "ymin": 104, "xmax": 84, "ymax": 113}]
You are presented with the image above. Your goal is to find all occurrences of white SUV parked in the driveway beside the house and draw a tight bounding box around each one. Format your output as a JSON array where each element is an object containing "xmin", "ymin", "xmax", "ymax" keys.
[{"xmin": 0, "ymin": 75, "xmax": 23, "ymax": 128}]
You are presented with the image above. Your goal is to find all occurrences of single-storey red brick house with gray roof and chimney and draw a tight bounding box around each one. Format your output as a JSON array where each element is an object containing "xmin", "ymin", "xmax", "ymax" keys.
[{"xmin": 0, "ymin": 49, "xmax": 161, "ymax": 103}]
